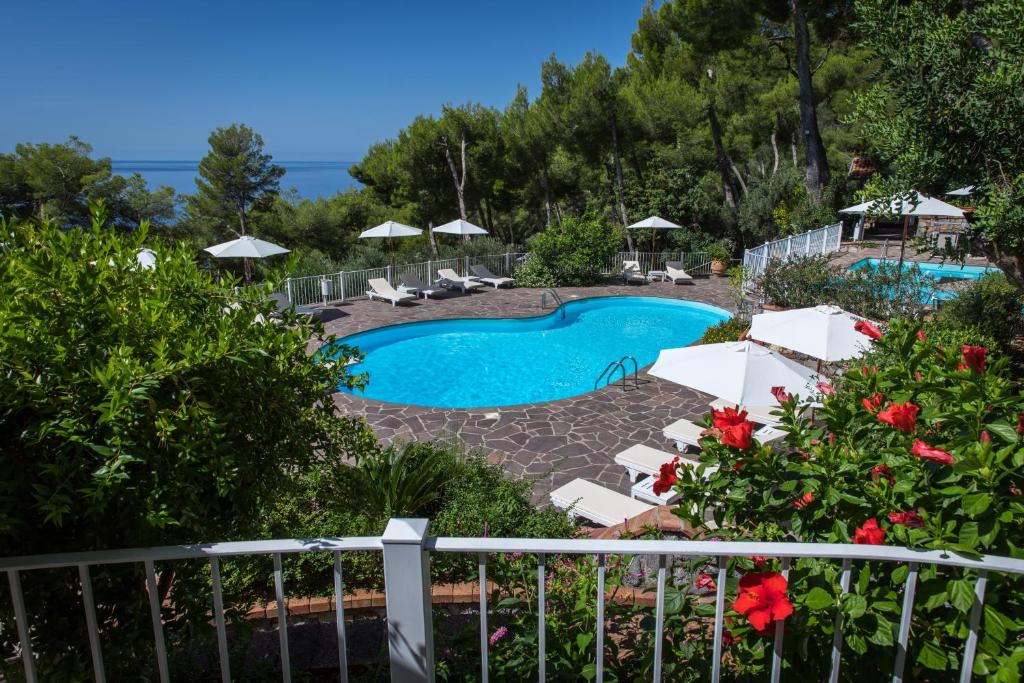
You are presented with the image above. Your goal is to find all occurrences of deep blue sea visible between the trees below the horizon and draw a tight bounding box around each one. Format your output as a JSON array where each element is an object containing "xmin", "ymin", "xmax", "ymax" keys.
[{"xmin": 112, "ymin": 160, "xmax": 359, "ymax": 200}]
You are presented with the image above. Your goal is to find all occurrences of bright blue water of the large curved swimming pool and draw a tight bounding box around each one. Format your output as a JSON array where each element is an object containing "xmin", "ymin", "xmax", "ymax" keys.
[{"xmin": 324, "ymin": 295, "xmax": 729, "ymax": 408}]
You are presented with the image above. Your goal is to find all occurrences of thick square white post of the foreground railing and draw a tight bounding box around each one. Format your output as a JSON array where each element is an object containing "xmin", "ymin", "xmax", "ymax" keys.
[{"xmin": 381, "ymin": 519, "xmax": 434, "ymax": 683}]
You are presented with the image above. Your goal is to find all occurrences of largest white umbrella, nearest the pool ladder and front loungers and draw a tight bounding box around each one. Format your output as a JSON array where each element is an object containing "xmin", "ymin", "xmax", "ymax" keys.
[{"xmin": 647, "ymin": 341, "xmax": 818, "ymax": 405}]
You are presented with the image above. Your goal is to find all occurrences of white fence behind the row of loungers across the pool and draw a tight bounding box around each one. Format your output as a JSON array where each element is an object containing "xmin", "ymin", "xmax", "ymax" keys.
[{"xmin": 278, "ymin": 252, "xmax": 711, "ymax": 306}]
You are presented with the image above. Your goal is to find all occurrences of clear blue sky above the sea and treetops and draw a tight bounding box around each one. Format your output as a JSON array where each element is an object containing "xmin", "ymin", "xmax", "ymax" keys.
[{"xmin": 0, "ymin": 0, "xmax": 643, "ymax": 161}]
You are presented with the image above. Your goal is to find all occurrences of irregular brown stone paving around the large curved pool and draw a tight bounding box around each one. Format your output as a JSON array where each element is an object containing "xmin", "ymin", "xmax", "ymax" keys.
[{"xmin": 311, "ymin": 279, "xmax": 734, "ymax": 503}]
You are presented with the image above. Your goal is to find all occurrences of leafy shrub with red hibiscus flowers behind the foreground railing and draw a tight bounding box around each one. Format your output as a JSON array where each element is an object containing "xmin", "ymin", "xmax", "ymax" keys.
[{"xmin": 676, "ymin": 321, "xmax": 1024, "ymax": 680}]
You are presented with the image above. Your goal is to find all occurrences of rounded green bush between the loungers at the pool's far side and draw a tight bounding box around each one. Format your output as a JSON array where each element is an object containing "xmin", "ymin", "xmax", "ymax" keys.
[{"xmin": 514, "ymin": 214, "xmax": 623, "ymax": 287}]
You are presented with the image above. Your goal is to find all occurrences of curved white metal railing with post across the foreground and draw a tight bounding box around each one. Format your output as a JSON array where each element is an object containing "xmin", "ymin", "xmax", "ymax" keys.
[{"xmin": 0, "ymin": 519, "xmax": 1024, "ymax": 683}]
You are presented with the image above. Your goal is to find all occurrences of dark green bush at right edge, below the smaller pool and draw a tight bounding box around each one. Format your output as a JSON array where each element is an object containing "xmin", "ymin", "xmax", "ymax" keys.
[{"xmin": 935, "ymin": 272, "xmax": 1021, "ymax": 346}]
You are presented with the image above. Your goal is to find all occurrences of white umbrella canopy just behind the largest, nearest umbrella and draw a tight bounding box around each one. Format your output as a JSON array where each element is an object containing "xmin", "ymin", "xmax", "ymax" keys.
[{"xmin": 749, "ymin": 306, "xmax": 869, "ymax": 362}]
